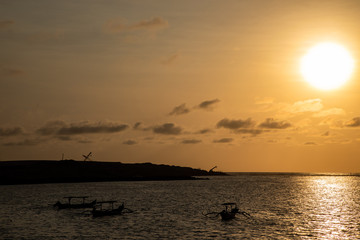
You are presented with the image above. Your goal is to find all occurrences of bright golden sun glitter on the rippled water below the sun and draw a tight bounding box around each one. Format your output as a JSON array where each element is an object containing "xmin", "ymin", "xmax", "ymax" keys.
[{"xmin": 303, "ymin": 176, "xmax": 359, "ymax": 239}]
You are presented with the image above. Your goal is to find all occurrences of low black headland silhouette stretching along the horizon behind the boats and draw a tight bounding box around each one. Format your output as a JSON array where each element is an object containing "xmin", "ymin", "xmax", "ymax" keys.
[{"xmin": 0, "ymin": 160, "xmax": 226, "ymax": 185}]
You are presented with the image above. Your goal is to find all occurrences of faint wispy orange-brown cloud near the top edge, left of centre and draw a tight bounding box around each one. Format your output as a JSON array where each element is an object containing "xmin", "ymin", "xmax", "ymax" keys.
[{"xmin": 104, "ymin": 17, "xmax": 169, "ymax": 33}]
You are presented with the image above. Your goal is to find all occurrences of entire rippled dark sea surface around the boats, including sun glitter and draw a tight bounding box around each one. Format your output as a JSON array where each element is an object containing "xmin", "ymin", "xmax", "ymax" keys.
[{"xmin": 0, "ymin": 175, "xmax": 360, "ymax": 239}]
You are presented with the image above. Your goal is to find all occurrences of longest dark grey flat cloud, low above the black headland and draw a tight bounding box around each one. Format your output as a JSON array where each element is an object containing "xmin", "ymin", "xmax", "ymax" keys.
[{"xmin": 37, "ymin": 121, "xmax": 129, "ymax": 135}]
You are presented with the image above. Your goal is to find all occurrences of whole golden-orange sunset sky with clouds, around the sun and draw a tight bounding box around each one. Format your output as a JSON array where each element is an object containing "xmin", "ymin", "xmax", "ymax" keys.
[{"xmin": 0, "ymin": 0, "xmax": 360, "ymax": 172}]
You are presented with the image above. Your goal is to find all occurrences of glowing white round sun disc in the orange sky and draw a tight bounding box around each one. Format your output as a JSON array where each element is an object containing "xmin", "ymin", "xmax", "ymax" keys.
[{"xmin": 300, "ymin": 42, "xmax": 355, "ymax": 90}]
